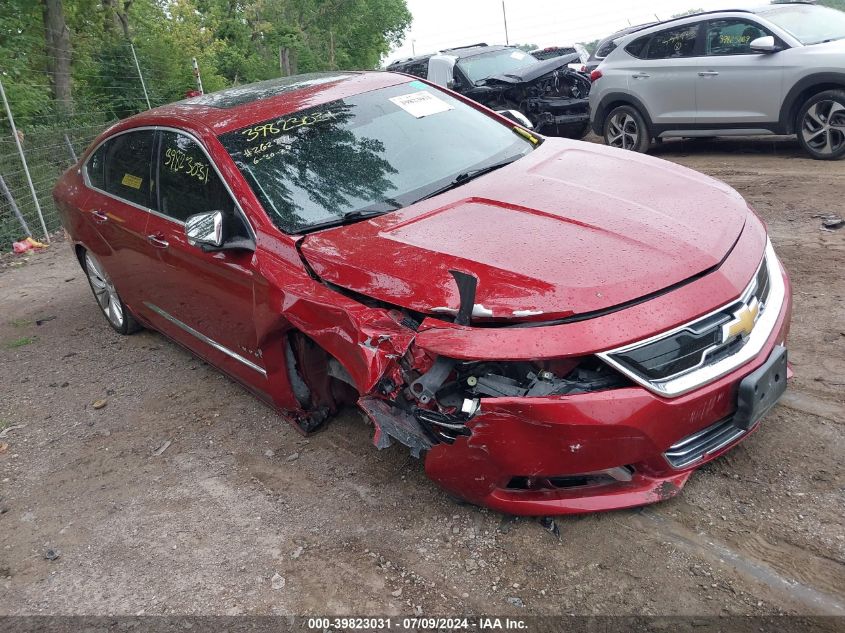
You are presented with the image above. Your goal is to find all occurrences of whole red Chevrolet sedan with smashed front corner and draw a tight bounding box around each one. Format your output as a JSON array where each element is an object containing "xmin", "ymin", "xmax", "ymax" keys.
[{"xmin": 54, "ymin": 73, "xmax": 790, "ymax": 515}]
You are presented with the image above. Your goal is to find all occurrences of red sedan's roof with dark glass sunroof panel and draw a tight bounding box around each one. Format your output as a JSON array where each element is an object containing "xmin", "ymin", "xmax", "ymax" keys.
[{"xmin": 110, "ymin": 71, "xmax": 413, "ymax": 135}]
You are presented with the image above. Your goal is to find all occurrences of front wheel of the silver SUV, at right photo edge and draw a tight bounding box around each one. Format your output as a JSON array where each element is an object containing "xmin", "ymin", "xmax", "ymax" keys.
[{"xmin": 797, "ymin": 90, "xmax": 845, "ymax": 160}]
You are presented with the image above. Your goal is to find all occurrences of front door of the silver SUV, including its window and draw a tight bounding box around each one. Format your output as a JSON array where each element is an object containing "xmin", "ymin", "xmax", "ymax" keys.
[{"xmin": 695, "ymin": 18, "xmax": 784, "ymax": 128}]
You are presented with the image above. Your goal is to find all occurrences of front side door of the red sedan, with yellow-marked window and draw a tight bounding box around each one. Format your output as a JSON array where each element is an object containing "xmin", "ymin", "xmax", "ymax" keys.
[{"xmin": 145, "ymin": 130, "xmax": 266, "ymax": 390}]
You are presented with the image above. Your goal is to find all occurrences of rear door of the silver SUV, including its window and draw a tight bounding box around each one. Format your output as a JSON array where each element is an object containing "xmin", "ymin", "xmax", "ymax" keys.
[{"xmin": 625, "ymin": 22, "xmax": 701, "ymax": 126}]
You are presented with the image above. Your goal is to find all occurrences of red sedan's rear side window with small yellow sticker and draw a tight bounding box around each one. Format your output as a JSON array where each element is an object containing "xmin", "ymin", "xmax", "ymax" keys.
[{"xmin": 86, "ymin": 130, "xmax": 154, "ymax": 208}]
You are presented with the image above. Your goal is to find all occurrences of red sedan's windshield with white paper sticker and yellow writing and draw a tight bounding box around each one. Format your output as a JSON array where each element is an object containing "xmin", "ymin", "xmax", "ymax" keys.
[{"xmin": 220, "ymin": 81, "xmax": 533, "ymax": 233}]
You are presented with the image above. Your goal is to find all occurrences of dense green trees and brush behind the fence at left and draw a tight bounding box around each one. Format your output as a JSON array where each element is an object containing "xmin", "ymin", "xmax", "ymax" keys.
[{"xmin": 0, "ymin": 0, "xmax": 411, "ymax": 250}]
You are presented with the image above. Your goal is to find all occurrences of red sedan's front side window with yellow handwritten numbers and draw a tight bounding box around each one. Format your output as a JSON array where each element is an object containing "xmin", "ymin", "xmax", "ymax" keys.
[{"xmin": 157, "ymin": 131, "xmax": 248, "ymax": 237}]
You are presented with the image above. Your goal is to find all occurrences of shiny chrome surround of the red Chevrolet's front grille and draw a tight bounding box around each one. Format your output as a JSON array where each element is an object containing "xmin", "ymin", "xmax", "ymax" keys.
[{"xmin": 597, "ymin": 239, "xmax": 786, "ymax": 398}]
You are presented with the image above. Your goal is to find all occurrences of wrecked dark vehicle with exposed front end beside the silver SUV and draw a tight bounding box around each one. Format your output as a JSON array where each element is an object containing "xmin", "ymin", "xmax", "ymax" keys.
[{"xmin": 388, "ymin": 44, "xmax": 590, "ymax": 138}]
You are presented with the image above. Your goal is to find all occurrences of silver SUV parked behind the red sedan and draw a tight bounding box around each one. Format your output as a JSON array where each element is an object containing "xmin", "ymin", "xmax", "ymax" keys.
[{"xmin": 590, "ymin": 2, "xmax": 845, "ymax": 160}]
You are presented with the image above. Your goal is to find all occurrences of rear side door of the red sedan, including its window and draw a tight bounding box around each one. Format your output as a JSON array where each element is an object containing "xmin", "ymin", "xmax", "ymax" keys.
[{"xmin": 82, "ymin": 129, "xmax": 155, "ymax": 312}]
